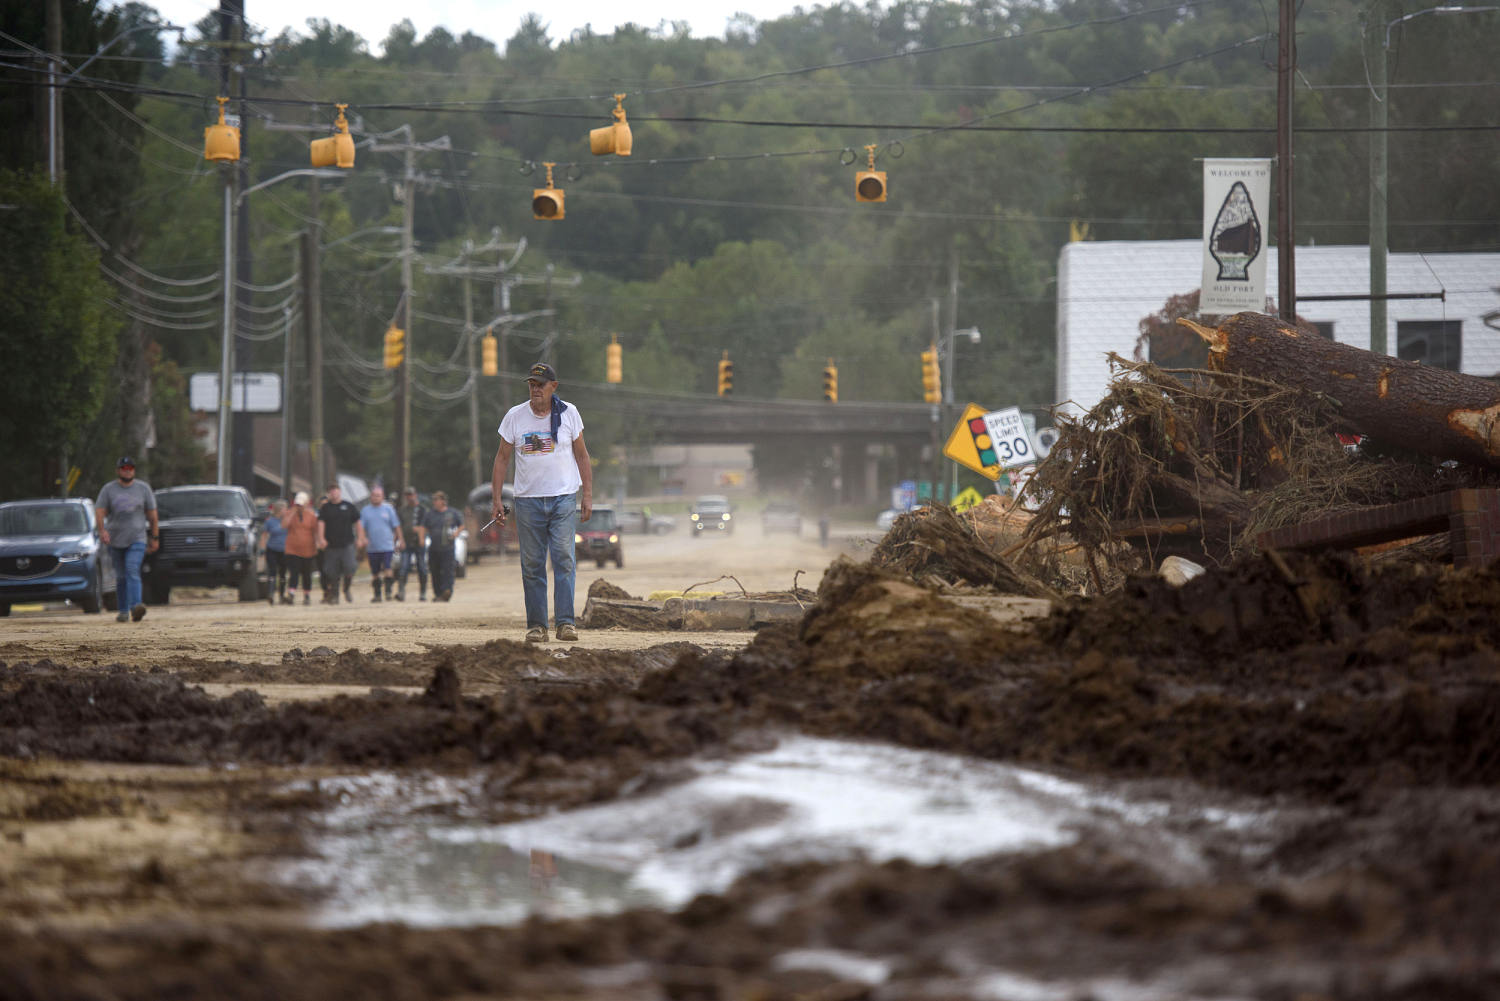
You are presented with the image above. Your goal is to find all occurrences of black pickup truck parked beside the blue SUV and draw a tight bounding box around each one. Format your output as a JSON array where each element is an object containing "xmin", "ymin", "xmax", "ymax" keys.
[{"xmin": 141, "ymin": 483, "xmax": 266, "ymax": 605}]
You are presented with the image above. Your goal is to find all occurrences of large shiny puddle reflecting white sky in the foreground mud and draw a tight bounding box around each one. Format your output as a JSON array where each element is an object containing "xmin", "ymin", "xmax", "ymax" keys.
[{"xmin": 272, "ymin": 737, "xmax": 1275, "ymax": 927}]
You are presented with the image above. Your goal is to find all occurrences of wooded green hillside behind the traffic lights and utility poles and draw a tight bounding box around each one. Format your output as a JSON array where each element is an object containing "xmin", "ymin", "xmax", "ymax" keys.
[{"xmin": 0, "ymin": 0, "xmax": 1500, "ymax": 494}]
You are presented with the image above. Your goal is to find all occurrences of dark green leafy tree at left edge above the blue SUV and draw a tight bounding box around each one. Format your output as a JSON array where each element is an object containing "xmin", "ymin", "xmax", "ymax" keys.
[{"xmin": 0, "ymin": 171, "xmax": 117, "ymax": 497}]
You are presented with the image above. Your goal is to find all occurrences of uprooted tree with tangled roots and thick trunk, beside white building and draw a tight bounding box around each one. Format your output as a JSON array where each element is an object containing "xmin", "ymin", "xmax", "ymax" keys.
[{"xmin": 1028, "ymin": 314, "xmax": 1500, "ymax": 581}]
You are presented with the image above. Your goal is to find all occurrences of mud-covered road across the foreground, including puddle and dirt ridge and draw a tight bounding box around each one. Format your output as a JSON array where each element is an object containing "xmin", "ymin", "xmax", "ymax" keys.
[{"xmin": 0, "ymin": 533, "xmax": 1500, "ymax": 1001}]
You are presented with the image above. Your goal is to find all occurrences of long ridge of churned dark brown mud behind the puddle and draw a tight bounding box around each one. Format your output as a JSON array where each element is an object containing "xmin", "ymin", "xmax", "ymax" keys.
[{"xmin": 0, "ymin": 557, "xmax": 1500, "ymax": 804}]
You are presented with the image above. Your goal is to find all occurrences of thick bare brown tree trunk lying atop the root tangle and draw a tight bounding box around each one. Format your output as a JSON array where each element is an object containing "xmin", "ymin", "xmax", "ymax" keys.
[{"xmin": 1178, "ymin": 312, "xmax": 1500, "ymax": 467}]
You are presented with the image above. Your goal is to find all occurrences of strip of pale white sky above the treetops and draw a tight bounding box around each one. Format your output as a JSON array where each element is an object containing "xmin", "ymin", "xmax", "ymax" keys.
[{"xmin": 133, "ymin": 0, "xmax": 815, "ymax": 56}]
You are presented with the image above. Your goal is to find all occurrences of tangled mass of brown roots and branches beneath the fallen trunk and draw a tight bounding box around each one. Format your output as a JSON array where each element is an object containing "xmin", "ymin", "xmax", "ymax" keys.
[{"xmin": 1020, "ymin": 340, "xmax": 1500, "ymax": 590}]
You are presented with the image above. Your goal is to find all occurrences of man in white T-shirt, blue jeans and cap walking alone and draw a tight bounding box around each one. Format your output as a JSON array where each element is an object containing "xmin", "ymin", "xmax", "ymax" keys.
[{"xmin": 492, "ymin": 362, "xmax": 594, "ymax": 642}]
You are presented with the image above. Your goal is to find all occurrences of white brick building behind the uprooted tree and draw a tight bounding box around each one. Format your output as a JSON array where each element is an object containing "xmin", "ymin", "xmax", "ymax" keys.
[{"xmin": 1058, "ymin": 240, "xmax": 1500, "ymax": 411}]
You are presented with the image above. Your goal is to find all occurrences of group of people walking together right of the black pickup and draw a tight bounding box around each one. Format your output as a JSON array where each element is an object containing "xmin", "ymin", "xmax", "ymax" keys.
[{"xmin": 261, "ymin": 483, "xmax": 464, "ymax": 605}]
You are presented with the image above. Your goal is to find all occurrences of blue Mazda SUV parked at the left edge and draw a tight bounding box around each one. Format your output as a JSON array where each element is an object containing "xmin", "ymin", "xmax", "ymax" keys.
[{"xmin": 0, "ymin": 497, "xmax": 114, "ymax": 615}]
